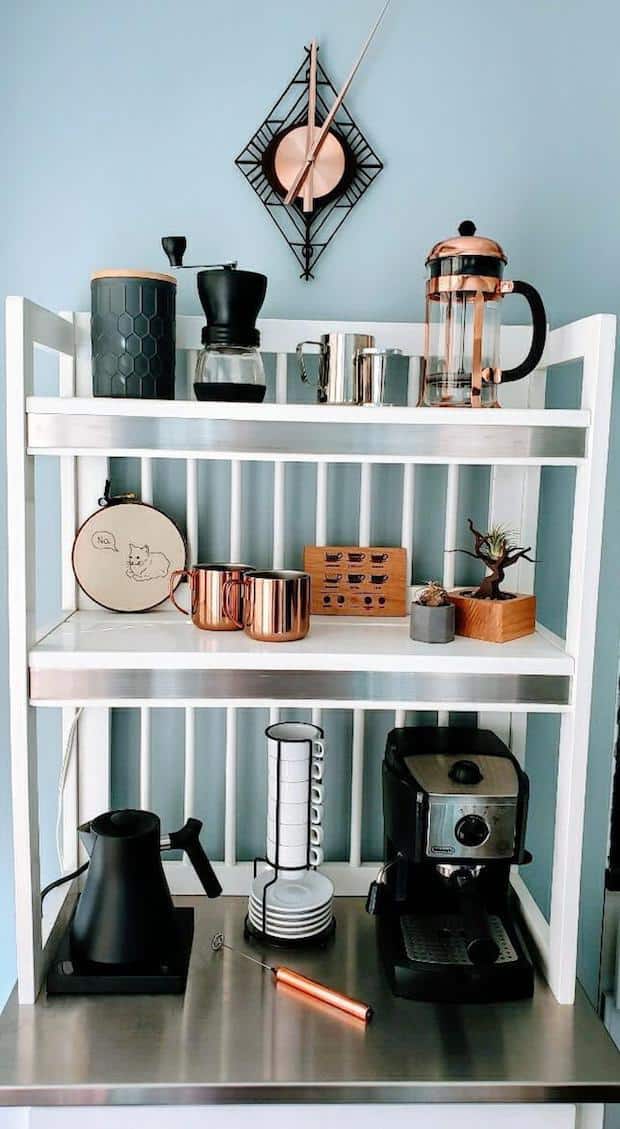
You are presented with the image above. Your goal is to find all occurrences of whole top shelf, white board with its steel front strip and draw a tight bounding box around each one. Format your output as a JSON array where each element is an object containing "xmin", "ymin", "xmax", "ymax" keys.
[{"xmin": 27, "ymin": 396, "xmax": 590, "ymax": 465}]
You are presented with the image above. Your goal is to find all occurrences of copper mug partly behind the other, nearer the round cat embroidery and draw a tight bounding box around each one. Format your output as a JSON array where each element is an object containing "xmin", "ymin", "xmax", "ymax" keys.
[{"xmin": 171, "ymin": 565, "xmax": 252, "ymax": 631}]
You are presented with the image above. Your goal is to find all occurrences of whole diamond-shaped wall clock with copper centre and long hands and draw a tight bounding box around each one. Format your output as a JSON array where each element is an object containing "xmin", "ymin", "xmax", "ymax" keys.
[{"xmin": 236, "ymin": 21, "xmax": 390, "ymax": 279}]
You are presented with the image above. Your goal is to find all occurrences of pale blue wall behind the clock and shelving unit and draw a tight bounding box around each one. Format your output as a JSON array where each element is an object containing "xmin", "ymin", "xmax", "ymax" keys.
[{"xmin": 0, "ymin": 0, "xmax": 620, "ymax": 998}]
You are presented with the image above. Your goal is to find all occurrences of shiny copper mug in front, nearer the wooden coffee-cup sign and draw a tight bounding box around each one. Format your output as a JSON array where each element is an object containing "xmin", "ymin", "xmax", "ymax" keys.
[{"xmin": 224, "ymin": 571, "xmax": 311, "ymax": 642}]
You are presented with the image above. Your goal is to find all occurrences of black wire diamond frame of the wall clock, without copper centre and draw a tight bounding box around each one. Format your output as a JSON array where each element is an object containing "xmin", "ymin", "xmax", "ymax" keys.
[{"xmin": 235, "ymin": 47, "xmax": 383, "ymax": 279}]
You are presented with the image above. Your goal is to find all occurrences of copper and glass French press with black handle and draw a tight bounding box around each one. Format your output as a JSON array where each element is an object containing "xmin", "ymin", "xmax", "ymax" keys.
[{"xmin": 419, "ymin": 220, "xmax": 547, "ymax": 408}]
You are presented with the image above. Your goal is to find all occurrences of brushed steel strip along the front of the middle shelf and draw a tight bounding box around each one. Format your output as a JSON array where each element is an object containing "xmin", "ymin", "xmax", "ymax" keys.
[{"xmin": 30, "ymin": 668, "xmax": 570, "ymax": 707}]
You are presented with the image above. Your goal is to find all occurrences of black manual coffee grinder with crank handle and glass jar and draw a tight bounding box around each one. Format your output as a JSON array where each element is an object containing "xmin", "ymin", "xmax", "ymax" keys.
[{"xmin": 161, "ymin": 235, "xmax": 267, "ymax": 403}]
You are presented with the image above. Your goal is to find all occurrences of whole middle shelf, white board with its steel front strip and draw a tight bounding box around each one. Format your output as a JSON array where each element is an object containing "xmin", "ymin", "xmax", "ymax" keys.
[{"xmin": 29, "ymin": 611, "xmax": 574, "ymax": 708}]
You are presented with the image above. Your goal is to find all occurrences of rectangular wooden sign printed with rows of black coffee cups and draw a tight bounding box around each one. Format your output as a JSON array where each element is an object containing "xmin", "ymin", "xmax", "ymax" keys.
[{"xmin": 304, "ymin": 545, "xmax": 407, "ymax": 616}]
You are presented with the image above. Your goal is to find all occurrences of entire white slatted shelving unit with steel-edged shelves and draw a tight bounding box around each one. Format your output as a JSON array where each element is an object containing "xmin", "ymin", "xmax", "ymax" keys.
[{"xmin": 7, "ymin": 298, "xmax": 615, "ymax": 1004}]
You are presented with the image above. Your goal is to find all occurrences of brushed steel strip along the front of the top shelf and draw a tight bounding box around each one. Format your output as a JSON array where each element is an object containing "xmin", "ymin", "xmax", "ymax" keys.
[{"xmin": 27, "ymin": 409, "xmax": 587, "ymax": 463}]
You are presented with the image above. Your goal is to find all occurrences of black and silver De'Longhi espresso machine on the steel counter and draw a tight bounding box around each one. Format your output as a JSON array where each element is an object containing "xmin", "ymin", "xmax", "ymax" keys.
[{"xmin": 367, "ymin": 726, "xmax": 533, "ymax": 1003}]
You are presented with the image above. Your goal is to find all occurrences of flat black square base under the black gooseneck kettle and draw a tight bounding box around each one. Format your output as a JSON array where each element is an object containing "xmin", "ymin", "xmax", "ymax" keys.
[{"xmin": 47, "ymin": 905, "xmax": 194, "ymax": 996}]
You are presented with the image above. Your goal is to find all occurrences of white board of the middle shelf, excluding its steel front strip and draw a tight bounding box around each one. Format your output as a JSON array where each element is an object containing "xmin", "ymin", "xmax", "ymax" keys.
[{"xmin": 30, "ymin": 611, "xmax": 573, "ymax": 674}]
